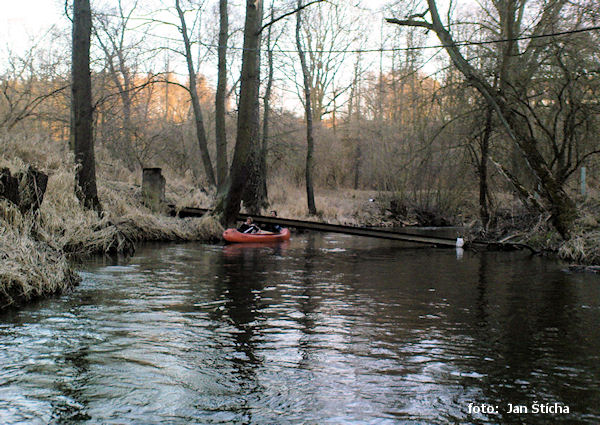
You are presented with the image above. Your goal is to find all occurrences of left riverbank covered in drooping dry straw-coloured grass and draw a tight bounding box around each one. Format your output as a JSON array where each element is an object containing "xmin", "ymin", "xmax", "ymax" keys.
[{"xmin": 0, "ymin": 161, "xmax": 223, "ymax": 310}]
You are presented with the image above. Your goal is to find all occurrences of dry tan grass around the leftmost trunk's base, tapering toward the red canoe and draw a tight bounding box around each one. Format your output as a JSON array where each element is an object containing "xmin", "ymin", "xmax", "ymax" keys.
[{"xmin": 34, "ymin": 166, "xmax": 223, "ymax": 256}]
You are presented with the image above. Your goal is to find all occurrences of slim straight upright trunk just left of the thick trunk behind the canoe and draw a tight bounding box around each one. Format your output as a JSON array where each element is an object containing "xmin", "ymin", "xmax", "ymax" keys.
[{"xmin": 215, "ymin": 0, "xmax": 229, "ymax": 192}]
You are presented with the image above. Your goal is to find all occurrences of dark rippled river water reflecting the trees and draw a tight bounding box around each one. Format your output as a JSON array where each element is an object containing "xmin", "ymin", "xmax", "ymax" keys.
[{"xmin": 0, "ymin": 234, "xmax": 600, "ymax": 424}]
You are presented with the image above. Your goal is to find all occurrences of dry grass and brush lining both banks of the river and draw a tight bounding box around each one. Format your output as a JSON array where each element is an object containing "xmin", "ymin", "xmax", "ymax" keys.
[{"xmin": 0, "ymin": 132, "xmax": 600, "ymax": 309}]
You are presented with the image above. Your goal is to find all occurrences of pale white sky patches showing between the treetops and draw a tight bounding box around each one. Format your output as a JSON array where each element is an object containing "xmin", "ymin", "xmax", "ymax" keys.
[{"xmin": 0, "ymin": 0, "xmax": 445, "ymax": 114}]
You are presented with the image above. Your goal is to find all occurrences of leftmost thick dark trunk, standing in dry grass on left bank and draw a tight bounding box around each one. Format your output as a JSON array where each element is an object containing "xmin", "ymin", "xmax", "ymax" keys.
[{"xmin": 71, "ymin": 0, "xmax": 101, "ymax": 213}]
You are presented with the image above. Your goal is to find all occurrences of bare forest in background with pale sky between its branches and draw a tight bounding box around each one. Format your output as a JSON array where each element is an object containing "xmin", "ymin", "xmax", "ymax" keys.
[{"xmin": 0, "ymin": 0, "xmax": 600, "ymax": 235}]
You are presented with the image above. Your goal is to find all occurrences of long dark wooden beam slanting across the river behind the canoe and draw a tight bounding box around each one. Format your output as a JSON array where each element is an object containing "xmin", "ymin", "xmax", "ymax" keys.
[{"xmin": 170, "ymin": 205, "xmax": 487, "ymax": 247}]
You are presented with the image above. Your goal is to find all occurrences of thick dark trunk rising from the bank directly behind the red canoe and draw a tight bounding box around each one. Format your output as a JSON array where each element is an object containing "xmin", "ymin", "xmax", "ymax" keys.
[{"xmin": 215, "ymin": 0, "xmax": 262, "ymax": 225}]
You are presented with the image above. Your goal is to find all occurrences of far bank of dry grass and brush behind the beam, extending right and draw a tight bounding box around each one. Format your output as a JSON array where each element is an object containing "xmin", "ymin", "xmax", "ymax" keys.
[{"xmin": 269, "ymin": 182, "xmax": 600, "ymax": 270}]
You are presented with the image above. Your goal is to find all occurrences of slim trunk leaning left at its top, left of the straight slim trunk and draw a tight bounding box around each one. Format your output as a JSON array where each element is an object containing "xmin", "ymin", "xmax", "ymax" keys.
[{"xmin": 175, "ymin": 0, "xmax": 217, "ymax": 186}]
